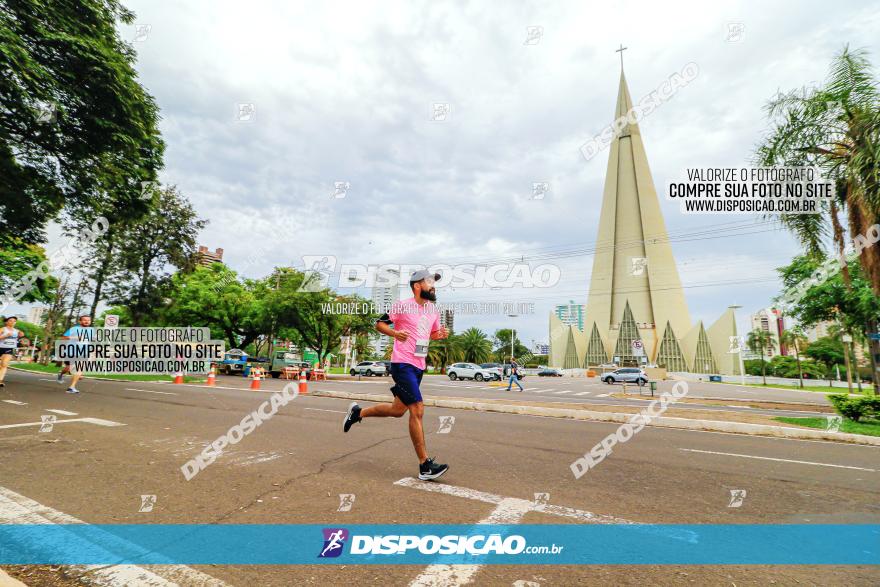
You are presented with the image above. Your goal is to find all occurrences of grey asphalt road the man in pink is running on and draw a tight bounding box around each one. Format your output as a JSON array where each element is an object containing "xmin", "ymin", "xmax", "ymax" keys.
[{"xmin": 0, "ymin": 372, "xmax": 880, "ymax": 586}]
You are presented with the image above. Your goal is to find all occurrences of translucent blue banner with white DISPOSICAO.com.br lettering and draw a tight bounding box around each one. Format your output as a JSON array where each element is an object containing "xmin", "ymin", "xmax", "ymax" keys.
[{"xmin": 0, "ymin": 524, "xmax": 880, "ymax": 565}]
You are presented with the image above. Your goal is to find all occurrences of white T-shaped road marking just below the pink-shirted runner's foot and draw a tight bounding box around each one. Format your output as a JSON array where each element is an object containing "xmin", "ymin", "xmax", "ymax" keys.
[{"xmin": 394, "ymin": 477, "xmax": 635, "ymax": 587}]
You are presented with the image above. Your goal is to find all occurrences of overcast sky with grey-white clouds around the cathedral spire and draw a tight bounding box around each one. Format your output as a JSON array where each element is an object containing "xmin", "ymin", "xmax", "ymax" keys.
[{"xmin": 13, "ymin": 0, "xmax": 880, "ymax": 341}]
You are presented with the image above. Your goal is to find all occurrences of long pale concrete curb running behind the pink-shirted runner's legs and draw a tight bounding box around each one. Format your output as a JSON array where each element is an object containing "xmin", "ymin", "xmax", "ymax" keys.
[{"xmin": 310, "ymin": 391, "xmax": 880, "ymax": 446}]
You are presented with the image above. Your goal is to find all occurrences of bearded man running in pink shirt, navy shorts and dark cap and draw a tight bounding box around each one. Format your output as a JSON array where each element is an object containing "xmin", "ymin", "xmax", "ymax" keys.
[{"xmin": 342, "ymin": 270, "xmax": 449, "ymax": 481}]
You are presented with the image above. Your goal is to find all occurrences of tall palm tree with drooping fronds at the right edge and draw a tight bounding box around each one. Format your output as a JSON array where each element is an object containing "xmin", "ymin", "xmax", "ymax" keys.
[{"xmin": 757, "ymin": 47, "xmax": 880, "ymax": 391}]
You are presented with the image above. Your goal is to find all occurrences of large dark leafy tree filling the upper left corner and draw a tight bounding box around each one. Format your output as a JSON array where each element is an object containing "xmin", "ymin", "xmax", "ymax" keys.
[{"xmin": 0, "ymin": 0, "xmax": 164, "ymax": 243}]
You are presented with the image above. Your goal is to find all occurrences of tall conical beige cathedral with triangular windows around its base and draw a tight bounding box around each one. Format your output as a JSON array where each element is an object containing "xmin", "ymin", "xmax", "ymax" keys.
[{"xmin": 550, "ymin": 68, "xmax": 739, "ymax": 374}]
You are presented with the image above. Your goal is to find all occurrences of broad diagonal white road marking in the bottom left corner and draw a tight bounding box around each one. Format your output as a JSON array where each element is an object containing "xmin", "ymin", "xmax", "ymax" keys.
[{"xmin": 0, "ymin": 487, "xmax": 226, "ymax": 587}]
